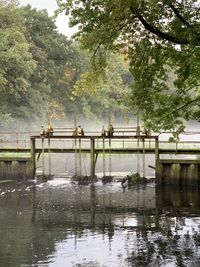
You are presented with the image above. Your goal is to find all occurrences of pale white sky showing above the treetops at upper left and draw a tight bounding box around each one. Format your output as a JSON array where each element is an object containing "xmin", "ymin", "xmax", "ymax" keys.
[{"xmin": 19, "ymin": 0, "xmax": 75, "ymax": 36}]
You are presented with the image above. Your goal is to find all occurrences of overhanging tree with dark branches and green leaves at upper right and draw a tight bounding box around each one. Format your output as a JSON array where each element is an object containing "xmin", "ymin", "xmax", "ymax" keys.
[{"xmin": 57, "ymin": 0, "xmax": 200, "ymax": 129}]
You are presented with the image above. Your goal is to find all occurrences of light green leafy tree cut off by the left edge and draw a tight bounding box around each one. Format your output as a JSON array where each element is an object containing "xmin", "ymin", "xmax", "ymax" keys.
[{"xmin": 0, "ymin": 1, "xmax": 36, "ymax": 126}]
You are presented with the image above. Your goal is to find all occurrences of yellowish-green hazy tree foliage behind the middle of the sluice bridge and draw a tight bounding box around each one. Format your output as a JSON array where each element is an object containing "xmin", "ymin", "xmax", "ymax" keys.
[{"xmin": 73, "ymin": 53, "xmax": 132, "ymax": 117}]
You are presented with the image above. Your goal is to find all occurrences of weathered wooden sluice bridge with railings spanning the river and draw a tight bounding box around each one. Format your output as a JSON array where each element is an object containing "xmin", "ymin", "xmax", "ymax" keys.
[{"xmin": 0, "ymin": 127, "xmax": 200, "ymax": 186}]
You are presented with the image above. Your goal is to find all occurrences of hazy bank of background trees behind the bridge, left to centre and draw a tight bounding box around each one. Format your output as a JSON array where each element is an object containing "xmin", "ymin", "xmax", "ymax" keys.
[{"xmin": 0, "ymin": 1, "xmax": 132, "ymax": 127}]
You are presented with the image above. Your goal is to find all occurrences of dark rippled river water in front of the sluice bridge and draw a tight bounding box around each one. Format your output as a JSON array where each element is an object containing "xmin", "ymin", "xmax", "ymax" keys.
[{"xmin": 0, "ymin": 179, "xmax": 200, "ymax": 267}]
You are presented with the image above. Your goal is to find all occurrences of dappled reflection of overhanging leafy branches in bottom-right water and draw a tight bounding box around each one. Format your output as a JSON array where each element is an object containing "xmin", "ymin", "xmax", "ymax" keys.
[{"xmin": 127, "ymin": 216, "xmax": 200, "ymax": 266}]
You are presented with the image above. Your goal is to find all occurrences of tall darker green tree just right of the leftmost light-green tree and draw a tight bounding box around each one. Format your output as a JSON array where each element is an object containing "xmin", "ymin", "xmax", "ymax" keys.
[{"xmin": 23, "ymin": 6, "xmax": 79, "ymax": 121}]
